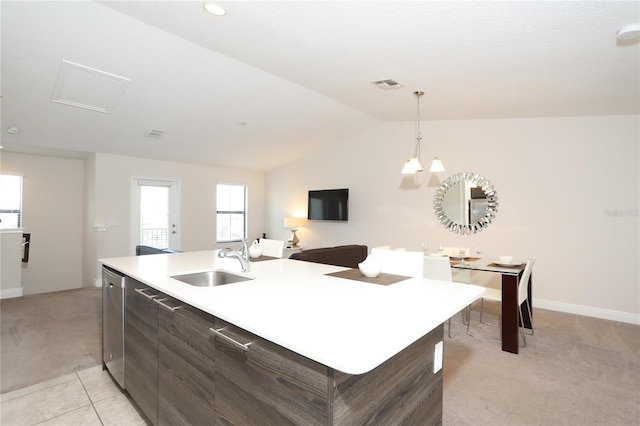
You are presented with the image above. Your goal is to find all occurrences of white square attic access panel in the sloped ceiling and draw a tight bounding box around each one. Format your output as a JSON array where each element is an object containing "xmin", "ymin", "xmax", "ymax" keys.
[{"xmin": 51, "ymin": 60, "xmax": 131, "ymax": 114}]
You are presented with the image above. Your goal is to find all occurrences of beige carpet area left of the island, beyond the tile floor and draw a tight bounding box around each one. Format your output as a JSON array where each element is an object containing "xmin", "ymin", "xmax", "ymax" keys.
[{"xmin": 0, "ymin": 287, "xmax": 102, "ymax": 393}]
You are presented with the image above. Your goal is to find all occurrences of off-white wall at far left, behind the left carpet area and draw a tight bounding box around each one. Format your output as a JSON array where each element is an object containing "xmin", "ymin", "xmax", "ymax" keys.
[{"xmin": 1, "ymin": 152, "xmax": 84, "ymax": 295}]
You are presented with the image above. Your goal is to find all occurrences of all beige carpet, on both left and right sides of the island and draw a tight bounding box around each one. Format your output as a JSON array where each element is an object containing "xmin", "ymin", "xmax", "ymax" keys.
[{"xmin": 0, "ymin": 288, "xmax": 640, "ymax": 426}]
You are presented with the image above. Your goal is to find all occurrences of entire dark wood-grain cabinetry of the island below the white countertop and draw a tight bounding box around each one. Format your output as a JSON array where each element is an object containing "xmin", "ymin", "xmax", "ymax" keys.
[{"xmin": 125, "ymin": 278, "xmax": 443, "ymax": 425}]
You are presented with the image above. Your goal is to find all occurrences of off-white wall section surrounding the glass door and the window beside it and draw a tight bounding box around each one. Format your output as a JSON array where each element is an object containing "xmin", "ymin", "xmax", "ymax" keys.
[{"xmin": 85, "ymin": 153, "xmax": 265, "ymax": 288}]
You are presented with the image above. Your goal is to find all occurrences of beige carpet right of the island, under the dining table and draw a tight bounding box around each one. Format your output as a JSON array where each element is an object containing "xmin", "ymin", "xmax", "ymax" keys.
[{"xmin": 443, "ymin": 309, "xmax": 640, "ymax": 426}]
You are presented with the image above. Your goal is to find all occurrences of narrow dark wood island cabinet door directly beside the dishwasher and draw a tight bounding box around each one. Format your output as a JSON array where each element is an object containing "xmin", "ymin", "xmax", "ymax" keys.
[{"xmin": 124, "ymin": 277, "xmax": 159, "ymax": 424}]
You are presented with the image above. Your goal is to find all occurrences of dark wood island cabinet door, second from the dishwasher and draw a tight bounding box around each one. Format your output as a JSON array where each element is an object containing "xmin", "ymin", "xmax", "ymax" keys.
[{"xmin": 158, "ymin": 298, "xmax": 215, "ymax": 425}]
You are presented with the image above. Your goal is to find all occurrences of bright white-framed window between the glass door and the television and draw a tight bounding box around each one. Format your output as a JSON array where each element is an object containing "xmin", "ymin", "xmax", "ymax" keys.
[{"xmin": 216, "ymin": 184, "xmax": 247, "ymax": 243}]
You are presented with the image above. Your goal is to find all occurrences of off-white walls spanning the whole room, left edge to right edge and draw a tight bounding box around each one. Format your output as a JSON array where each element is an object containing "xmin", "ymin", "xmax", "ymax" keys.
[{"xmin": 1, "ymin": 115, "xmax": 640, "ymax": 323}]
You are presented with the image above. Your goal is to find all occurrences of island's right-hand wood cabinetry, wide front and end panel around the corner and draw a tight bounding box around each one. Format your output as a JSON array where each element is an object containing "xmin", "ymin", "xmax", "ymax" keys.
[{"xmin": 215, "ymin": 320, "xmax": 443, "ymax": 426}]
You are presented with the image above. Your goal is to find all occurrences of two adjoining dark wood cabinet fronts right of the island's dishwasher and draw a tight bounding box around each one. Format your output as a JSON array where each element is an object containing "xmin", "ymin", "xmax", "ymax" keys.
[{"xmin": 124, "ymin": 277, "xmax": 215, "ymax": 425}]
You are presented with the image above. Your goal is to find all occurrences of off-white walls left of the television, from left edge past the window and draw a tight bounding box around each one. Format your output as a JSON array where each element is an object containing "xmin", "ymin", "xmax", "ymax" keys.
[{"xmin": 1, "ymin": 152, "xmax": 266, "ymax": 295}]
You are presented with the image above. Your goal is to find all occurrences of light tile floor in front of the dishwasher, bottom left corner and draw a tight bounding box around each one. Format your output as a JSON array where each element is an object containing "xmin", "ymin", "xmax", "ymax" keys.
[{"xmin": 0, "ymin": 365, "xmax": 151, "ymax": 426}]
